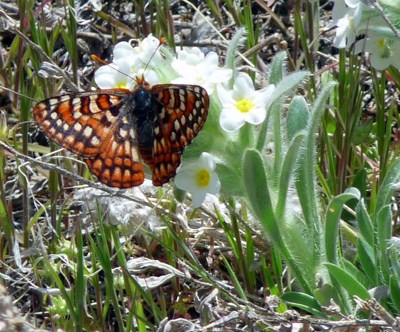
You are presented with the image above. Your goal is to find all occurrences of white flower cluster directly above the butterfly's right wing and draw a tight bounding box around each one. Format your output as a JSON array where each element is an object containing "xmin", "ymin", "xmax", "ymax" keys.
[{"xmin": 171, "ymin": 47, "xmax": 232, "ymax": 95}]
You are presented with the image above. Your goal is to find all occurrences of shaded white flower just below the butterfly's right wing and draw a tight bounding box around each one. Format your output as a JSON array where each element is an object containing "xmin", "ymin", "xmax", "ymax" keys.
[{"xmin": 175, "ymin": 152, "xmax": 221, "ymax": 207}]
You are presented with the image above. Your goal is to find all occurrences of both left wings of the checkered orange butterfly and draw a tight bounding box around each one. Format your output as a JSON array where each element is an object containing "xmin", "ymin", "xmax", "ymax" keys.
[{"xmin": 33, "ymin": 89, "xmax": 144, "ymax": 188}]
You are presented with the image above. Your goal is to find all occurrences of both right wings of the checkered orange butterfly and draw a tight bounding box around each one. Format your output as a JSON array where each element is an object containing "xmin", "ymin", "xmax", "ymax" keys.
[{"xmin": 148, "ymin": 84, "xmax": 209, "ymax": 186}]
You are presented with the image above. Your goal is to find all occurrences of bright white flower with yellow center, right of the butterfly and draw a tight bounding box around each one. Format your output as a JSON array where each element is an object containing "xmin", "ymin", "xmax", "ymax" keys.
[{"xmin": 218, "ymin": 73, "xmax": 275, "ymax": 132}]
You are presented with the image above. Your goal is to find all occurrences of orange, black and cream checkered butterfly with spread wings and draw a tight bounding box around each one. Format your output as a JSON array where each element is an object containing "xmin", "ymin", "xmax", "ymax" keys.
[{"xmin": 33, "ymin": 79, "xmax": 210, "ymax": 188}]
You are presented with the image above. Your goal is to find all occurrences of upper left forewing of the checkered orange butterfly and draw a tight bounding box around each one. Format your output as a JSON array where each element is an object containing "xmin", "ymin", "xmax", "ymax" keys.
[{"xmin": 33, "ymin": 90, "xmax": 129, "ymax": 157}]
